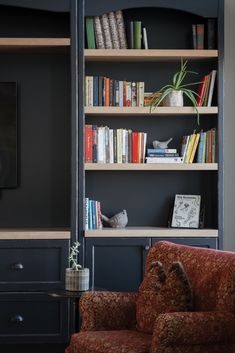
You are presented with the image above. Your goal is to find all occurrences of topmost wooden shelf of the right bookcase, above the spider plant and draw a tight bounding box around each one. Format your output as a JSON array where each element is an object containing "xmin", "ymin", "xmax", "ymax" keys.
[{"xmin": 85, "ymin": 49, "xmax": 218, "ymax": 62}]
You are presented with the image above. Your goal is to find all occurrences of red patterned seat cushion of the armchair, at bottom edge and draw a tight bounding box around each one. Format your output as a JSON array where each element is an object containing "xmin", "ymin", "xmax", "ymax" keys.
[{"xmin": 66, "ymin": 330, "xmax": 152, "ymax": 353}]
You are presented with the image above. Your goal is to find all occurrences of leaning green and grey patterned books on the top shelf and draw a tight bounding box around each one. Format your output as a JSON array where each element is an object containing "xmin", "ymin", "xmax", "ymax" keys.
[{"xmin": 85, "ymin": 10, "xmax": 127, "ymax": 49}]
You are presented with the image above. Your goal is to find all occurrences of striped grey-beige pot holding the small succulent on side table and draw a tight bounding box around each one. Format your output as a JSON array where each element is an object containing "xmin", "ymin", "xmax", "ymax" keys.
[{"xmin": 65, "ymin": 268, "xmax": 90, "ymax": 291}]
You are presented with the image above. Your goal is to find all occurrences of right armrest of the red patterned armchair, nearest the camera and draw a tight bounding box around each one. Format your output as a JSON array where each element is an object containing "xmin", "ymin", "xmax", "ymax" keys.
[{"xmin": 151, "ymin": 311, "xmax": 235, "ymax": 352}]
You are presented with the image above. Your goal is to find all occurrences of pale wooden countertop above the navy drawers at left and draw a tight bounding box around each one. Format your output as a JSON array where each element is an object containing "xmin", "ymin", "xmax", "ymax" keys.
[{"xmin": 0, "ymin": 228, "xmax": 70, "ymax": 240}]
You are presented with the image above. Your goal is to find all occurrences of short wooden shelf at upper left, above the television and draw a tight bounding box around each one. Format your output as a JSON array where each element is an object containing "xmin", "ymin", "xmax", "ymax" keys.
[{"xmin": 0, "ymin": 38, "xmax": 70, "ymax": 51}]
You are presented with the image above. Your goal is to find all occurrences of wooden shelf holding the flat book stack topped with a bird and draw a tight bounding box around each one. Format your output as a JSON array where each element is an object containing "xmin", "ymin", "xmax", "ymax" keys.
[{"xmin": 85, "ymin": 163, "xmax": 218, "ymax": 171}]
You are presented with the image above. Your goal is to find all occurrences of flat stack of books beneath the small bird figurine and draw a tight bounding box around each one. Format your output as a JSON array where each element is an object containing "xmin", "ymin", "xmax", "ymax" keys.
[{"xmin": 146, "ymin": 148, "xmax": 183, "ymax": 163}]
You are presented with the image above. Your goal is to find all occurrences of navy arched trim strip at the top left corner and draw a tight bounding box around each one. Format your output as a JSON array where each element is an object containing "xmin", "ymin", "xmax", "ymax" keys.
[{"xmin": 0, "ymin": 0, "xmax": 70, "ymax": 12}]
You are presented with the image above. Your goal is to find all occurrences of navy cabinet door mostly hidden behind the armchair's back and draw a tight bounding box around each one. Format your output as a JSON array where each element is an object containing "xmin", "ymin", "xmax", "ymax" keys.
[{"xmin": 152, "ymin": 238, "xmax": 218, "ymax": 249}]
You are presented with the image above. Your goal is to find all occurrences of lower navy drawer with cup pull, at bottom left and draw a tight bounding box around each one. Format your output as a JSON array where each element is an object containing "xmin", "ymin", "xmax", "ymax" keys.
[{"xmin": 0, "ymin": 293, "xmax": 68, "ymax": 343}]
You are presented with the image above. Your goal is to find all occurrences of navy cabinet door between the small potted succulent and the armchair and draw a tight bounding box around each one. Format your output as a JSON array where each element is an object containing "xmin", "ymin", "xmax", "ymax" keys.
[{"xmin": 86, "ymin": 238, "xmax": 150, "ymax": 291}]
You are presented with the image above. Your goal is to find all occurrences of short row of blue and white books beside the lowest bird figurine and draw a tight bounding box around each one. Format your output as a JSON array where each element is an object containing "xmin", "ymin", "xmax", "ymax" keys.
[{"xmin": 85, "ymin": 197, "xmax": 102, "ymax": 230}]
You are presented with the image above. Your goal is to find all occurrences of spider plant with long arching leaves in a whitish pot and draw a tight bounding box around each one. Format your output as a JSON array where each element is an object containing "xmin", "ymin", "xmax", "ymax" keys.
[{"xmin": 150, "ymin": 59, "xmax": 201, "ymax": 124}]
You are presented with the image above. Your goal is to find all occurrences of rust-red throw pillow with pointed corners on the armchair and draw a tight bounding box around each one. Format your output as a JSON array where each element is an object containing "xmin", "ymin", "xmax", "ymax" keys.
[{"xmin": 136, "ymin": 262, "xmax": 192, "ymax": 334}]
